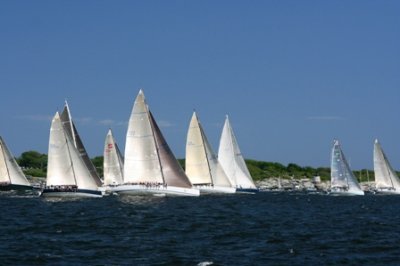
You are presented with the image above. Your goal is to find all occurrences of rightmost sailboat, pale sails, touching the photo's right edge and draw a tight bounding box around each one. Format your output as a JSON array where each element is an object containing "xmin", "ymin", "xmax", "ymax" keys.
[{"xmin": 374, "ymin": 139, "xmax": 400, "ymax": 194}]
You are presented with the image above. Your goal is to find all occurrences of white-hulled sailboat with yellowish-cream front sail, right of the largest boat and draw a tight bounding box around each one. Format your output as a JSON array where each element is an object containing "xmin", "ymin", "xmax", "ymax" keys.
[{"xmin": 185, "ymin": 112, "xmax": 236, "ymax": 193}]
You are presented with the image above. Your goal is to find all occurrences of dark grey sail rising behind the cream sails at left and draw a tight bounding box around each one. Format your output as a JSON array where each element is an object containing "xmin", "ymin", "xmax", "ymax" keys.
[{"xmin": 60, "ymin": 101, "xmax": 101, "ymax": 186}]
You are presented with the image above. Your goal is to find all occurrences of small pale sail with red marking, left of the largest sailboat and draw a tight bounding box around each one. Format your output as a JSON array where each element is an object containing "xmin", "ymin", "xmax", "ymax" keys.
[{"xmin": 104, "ymin": 129, "xmax": 124, "ymax": 186}]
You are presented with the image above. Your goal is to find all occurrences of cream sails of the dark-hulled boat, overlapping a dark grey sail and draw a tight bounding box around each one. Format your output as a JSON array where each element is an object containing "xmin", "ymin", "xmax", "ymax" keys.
[{"xmin": 46, "ymin": 112, "xmax": 98, "ymax": 190}]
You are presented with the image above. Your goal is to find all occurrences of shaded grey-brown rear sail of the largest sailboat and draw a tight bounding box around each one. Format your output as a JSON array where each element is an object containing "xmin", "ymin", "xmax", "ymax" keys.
[{"xmin": 149, "ymin": 111, "xmax": 192, "ymax": 188}]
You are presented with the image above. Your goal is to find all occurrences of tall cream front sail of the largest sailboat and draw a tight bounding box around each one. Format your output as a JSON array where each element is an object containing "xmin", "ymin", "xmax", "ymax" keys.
[{"xmin": 124, "ymin": 90, "xmax": 164, "ymax": 183}]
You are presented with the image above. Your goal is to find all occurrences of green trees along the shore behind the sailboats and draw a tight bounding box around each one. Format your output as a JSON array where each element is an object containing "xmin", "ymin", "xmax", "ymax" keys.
[{"xmin": 16, "ymin": 151, "xmax": 374, "ymax": 182}]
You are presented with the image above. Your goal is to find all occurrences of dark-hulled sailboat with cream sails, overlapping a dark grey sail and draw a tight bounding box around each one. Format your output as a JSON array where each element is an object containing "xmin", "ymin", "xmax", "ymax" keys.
[{"xmin": 41, "ymin": 112, "xmax": 102, "ymax": 197}]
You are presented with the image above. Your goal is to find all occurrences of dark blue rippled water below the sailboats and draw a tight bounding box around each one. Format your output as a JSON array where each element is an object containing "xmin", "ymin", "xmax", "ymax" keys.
[{"xmin": 0, "ymin": 193, "xmax": 400, "ymax": 265}]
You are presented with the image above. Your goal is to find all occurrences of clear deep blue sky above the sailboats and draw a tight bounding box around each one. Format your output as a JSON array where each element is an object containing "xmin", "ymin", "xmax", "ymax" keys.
[{"xmin": 0, "ymin": 0, "xmax": 400, "ymax": 169}]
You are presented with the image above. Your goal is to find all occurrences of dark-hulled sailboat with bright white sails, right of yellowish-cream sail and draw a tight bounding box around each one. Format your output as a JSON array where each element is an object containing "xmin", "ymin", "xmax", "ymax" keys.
[{"xmin": 218, "ymin": 116, "xmax": 258, "ymax": 193}]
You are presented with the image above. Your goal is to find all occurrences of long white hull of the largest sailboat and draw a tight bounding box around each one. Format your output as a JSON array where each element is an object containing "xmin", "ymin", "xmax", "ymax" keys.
[{"xmin": 109, "ymin": 185, "xmax": 200, "ymax": 197}]
